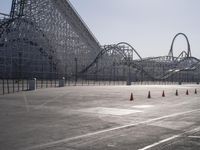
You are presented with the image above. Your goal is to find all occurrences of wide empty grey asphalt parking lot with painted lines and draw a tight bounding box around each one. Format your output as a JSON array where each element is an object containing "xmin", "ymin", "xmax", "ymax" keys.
[{"xmin": 0, "ymin": 85, "xmax": 200, "ymax": 150}]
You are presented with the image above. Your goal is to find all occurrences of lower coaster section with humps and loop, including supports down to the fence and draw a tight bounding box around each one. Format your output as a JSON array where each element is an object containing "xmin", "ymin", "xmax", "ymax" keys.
[{"xmin": 80, "ymin": 33, "xmax": 200, "ymax": 82}]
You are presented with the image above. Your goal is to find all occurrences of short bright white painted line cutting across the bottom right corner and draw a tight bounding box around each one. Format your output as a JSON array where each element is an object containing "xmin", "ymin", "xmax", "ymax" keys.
[{"xmin": 138, "ymin": 127, "xmax": 200, "ymax": 150}]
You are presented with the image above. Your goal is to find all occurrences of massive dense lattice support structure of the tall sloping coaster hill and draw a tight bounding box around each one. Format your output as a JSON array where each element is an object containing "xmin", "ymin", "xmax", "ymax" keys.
[{"xmin": 0, "ymin": 0, "xmax": 100, "ymax": 78}]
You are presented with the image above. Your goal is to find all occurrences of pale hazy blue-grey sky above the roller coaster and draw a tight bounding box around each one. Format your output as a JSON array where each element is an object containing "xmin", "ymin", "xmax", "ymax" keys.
[{"xmin": 0, "ymin": 0, "xmax": 200, "ymax": 58}]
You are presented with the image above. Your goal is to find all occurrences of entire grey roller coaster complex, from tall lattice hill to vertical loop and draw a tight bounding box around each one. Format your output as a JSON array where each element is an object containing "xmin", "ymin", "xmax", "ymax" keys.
[{"xmin": 0, "ymin": 0, "xmax": 200, "ymax": 83}]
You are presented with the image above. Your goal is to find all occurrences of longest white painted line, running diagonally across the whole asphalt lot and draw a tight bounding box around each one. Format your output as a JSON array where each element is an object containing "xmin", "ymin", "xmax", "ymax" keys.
[{"xmin": 26, "ymin": 109, "xmax": 200, "ymax": 150}]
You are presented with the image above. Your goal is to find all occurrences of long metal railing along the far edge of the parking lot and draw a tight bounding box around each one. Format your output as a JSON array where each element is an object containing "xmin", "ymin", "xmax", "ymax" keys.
[{"xmin": 0, "ymin": 78, "xmax": 199, "ymax": 95}]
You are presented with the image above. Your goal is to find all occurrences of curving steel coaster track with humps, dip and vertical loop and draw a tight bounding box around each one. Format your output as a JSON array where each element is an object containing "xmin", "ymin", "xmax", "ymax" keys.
[{"xmin": 79, "ymin": 33, "xmax": 200, "ymax": 80}]
